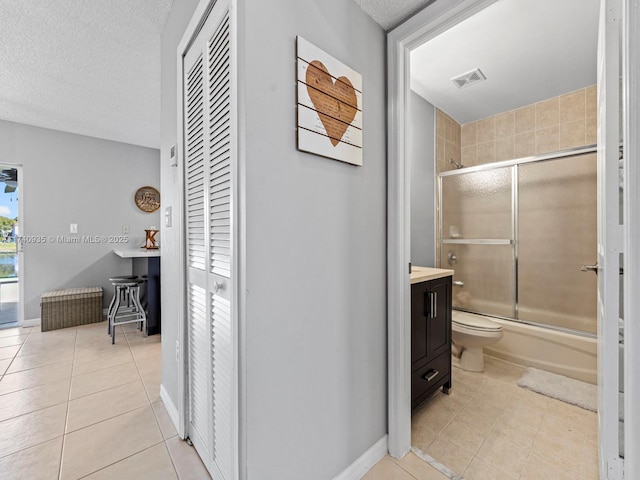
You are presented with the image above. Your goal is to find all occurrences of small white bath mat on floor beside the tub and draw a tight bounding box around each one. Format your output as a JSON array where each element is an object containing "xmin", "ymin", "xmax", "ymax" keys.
[{"xmin": 518, "ymin": 367, "xmax": 598, "ymax": 412}]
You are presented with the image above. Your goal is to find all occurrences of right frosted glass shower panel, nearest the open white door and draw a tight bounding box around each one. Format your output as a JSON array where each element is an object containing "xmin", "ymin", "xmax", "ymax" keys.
[{"xmin": 517, "ymin": 153, "xmax": 597, "ymax": 334}]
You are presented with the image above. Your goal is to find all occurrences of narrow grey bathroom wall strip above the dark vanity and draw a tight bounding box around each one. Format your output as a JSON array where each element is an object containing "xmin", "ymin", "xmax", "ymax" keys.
[{"xmin": 407, "ymin": 90, "xmax": 436, "ymax": 267}]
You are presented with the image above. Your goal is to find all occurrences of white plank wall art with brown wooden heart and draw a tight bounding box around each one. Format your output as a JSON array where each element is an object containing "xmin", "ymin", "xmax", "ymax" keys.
[{"xmin": 297, "ymin": 37, "xmax": 362, "ymax": 166}]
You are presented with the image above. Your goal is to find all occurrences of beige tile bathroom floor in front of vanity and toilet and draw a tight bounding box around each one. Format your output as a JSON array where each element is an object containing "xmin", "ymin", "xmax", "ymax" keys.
[{"xmin": 410, "ymin": 357, "xmax": 598, "ymax": 480}]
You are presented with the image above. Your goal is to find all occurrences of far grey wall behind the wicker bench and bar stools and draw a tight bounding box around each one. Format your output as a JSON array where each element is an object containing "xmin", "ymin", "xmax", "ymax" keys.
[{"xmin": 0, "ymin": 121, "xmax": 162, "ymax": 319}]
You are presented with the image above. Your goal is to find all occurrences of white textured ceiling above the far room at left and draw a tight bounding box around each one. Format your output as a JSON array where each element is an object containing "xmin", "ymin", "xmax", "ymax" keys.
[{"xmin": 0, "ymin": 0, "xmax": 173, "ymax": 148}]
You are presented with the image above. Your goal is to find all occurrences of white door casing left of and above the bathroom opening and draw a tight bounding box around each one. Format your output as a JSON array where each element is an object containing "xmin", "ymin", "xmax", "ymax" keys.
[{"xmin": 387, "ymin": 0, "xmax": 498, "ymax": 458}]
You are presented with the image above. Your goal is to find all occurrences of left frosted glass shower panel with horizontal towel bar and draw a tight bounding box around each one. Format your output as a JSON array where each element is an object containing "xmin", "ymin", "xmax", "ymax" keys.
[{"xmin": 440, "ymin": 167, "xmax": 515, "ymax": 318}]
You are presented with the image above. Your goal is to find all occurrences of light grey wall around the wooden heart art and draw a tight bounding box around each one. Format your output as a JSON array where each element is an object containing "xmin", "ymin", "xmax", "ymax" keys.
[{"xmin": 243, "ymin": 0, "xmax": 387, "ymax": 480}]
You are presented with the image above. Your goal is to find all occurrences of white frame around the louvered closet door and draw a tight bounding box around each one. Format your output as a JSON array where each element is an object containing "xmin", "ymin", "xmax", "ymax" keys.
[{"xmin": 176, "ymin": 0, "xmax": 247, "ymax": 480}]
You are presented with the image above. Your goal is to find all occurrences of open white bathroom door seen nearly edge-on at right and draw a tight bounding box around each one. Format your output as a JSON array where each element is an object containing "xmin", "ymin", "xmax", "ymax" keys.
[{"xmin": 597, "ymin": 0, "xmax": 624, "ymax": 480}]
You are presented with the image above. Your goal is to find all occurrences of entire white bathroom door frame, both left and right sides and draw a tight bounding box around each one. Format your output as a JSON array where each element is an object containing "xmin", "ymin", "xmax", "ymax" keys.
[{"xmin": 387, "ymin": 0, "xmax": 640, "ymax": 468}]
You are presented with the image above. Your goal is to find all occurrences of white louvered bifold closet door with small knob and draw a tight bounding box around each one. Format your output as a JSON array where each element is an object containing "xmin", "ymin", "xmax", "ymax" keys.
[{"xmin": 183, "ymin": 1, "xmax": 237, "ymax": 480}]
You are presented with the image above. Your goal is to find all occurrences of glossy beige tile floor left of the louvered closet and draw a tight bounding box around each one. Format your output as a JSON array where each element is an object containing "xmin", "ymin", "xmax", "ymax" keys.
[{"xmin": 0, "ymin": 322, "xmax": 210, "ymax": 480}]
